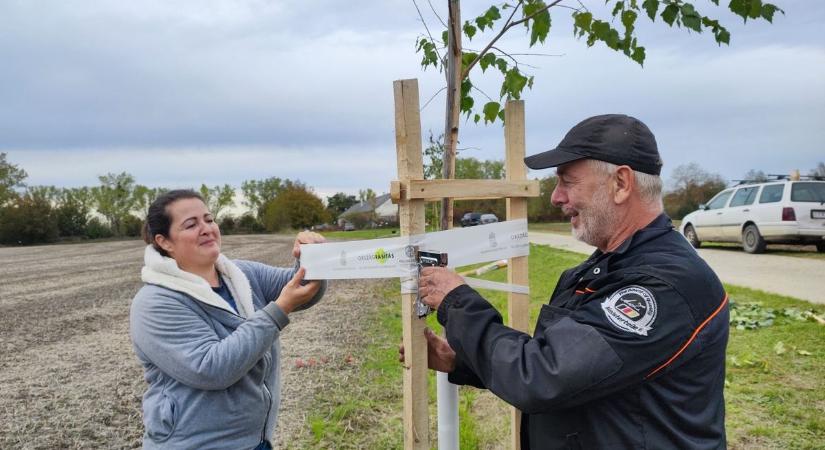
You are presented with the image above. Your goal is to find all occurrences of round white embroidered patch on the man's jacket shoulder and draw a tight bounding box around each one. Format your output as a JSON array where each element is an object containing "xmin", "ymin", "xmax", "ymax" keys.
[{"xmin": 602, "ymin": 285, "xmax": 656, "ymax": 336}]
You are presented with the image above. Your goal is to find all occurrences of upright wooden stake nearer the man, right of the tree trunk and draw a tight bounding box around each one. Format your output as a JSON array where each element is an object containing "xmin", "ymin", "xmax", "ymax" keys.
[{"xmin": 504, "ymin": 100, "xmax": 530, "ymax": 450}]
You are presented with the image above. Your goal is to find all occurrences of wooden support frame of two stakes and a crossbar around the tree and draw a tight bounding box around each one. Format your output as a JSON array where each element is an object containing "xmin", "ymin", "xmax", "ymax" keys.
[{"xmin": 391, "ymin": 79, "xmax": 539, "ymax": 450}]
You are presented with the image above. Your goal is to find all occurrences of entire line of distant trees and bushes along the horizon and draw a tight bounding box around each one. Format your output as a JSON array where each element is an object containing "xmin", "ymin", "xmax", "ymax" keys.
[{"xmin": 0, "ymin": 153, "xmax": 825, "ymax": 245}]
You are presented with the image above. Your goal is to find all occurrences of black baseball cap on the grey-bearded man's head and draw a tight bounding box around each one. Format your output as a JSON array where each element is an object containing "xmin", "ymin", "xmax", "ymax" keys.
[{"xmin": 524, "ymin": 114, "xmax": 662, "ymax": 175}]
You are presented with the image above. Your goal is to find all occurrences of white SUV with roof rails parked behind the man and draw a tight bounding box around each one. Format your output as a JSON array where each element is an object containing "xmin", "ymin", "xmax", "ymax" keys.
[{"xmin": 680, "ymin": 179, "xmax": 825, "ymax": 253}]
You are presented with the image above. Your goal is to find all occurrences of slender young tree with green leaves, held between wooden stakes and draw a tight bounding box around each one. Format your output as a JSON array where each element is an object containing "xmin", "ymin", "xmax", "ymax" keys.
[{"xmin": 413, "ymin": 0, "xmax": 784, "ymax": 228}]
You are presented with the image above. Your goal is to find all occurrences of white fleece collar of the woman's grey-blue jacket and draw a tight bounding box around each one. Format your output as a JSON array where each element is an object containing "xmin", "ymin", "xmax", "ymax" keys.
[{"xmin": 140, "ymin": 245, "xmax": 255, "ymax": 319}]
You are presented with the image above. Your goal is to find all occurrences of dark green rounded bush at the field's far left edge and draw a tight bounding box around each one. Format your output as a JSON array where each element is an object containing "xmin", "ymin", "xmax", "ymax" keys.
[{"xmin": 0, "ymin": 194, "xmax": 58, "ymax": 245}]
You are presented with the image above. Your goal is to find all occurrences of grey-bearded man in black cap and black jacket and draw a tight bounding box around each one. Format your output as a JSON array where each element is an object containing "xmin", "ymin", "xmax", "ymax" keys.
[{"xmin": 412, "ymin": 114, "xmax": 728, "ymax": 450}]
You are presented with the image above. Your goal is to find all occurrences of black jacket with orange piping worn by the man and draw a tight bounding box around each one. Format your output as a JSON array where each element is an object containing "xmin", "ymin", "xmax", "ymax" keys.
[{"xmin": 438, "ymin": 214, "xmax": 728, "ymax": 450}]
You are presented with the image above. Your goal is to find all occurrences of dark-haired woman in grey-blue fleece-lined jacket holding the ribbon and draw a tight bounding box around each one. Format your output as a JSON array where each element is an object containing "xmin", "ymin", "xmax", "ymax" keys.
[{"xmin": 130, "ymin": 190, "xmax": 325, "ymax": 449}]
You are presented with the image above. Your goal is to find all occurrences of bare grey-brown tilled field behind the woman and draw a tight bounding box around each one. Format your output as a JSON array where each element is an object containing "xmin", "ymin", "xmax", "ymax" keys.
[{"xmin": 0, "ymin": 235, "xmax": 374, "ymax": 449}]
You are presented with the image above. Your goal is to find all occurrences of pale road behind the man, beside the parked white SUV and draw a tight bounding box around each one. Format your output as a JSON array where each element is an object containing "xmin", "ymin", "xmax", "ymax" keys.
[{"xmin": 530, "ymin": 231, "xmax": 825, "ymax": 303}]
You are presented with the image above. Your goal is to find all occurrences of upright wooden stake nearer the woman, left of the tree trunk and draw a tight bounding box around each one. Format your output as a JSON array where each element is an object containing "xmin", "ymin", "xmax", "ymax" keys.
[{"xmin": 393, "ymin": 80, "xmax": 430, "ymax": 450}]
